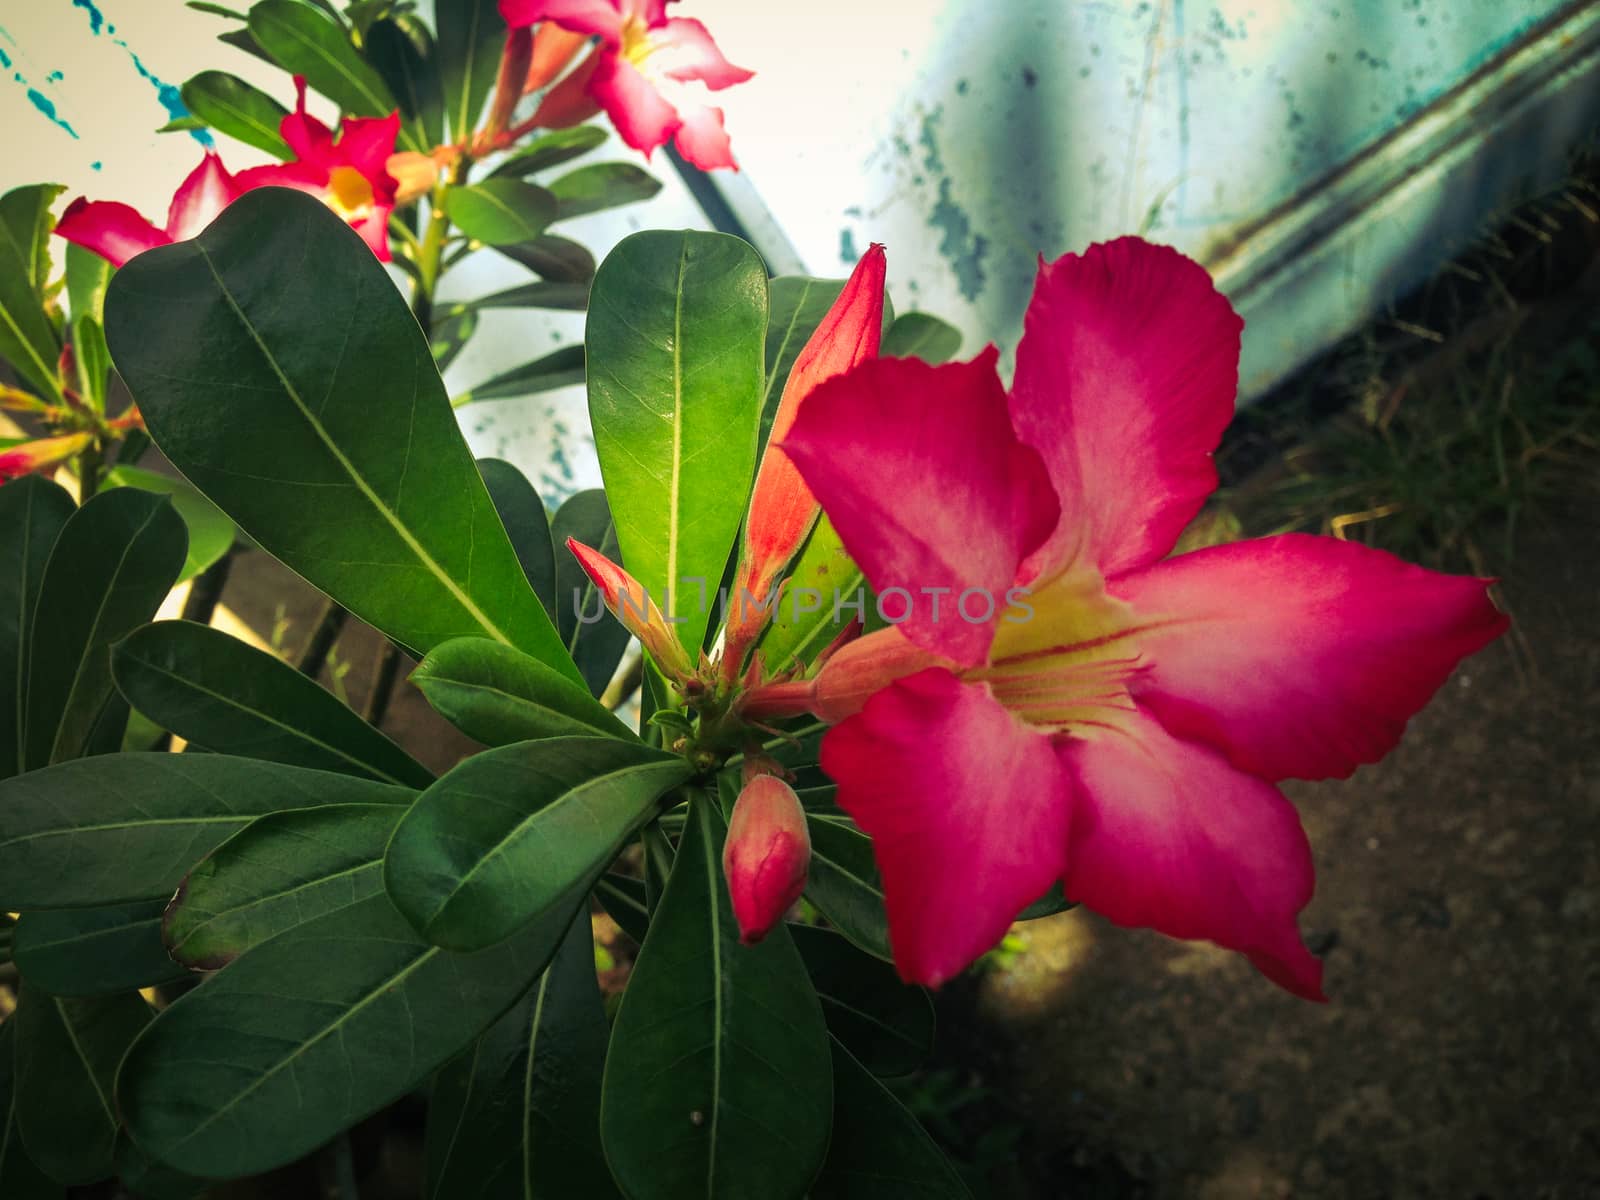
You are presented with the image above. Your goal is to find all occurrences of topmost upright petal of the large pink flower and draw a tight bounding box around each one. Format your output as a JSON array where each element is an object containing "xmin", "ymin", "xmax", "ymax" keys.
[{"xmin": 1011, "ymin": 237, "xmax": 1243, "ymax": 578}]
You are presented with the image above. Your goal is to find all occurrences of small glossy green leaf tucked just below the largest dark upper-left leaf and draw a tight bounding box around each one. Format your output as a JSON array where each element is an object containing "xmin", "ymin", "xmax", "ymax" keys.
[{"xmin": 411, "ymin": 637, "xmax": 635, "ymax": 746}]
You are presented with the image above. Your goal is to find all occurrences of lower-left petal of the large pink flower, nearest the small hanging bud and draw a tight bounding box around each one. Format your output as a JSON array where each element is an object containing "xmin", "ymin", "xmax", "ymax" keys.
[{"xmin": 822, "ymin": 667, "xmax": 1072, "ymax": 987}]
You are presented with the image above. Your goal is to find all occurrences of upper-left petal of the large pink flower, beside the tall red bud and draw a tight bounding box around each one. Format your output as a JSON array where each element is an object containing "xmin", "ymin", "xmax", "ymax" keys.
[{"xmin": 781, "ymin": 346, "xmax": 1058, "ymax": 666}]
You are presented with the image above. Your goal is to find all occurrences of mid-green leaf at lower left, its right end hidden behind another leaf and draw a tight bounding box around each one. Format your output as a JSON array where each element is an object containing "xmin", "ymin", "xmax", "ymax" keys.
[{"xmin": 163, "ymin": 803, "xmax": 405, "ymax": 971}]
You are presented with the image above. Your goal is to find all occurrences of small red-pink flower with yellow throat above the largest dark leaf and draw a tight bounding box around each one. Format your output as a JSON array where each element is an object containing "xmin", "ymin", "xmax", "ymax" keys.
[{"xmin": 238, "ymin": 75, "xmax": 400, "ymax": 262}]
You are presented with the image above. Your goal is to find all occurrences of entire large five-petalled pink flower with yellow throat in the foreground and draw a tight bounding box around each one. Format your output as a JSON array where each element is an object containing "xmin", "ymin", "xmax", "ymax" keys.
[{"xmin": 778, "ymin": 238, "xmax": 1507, "ymax": 998}]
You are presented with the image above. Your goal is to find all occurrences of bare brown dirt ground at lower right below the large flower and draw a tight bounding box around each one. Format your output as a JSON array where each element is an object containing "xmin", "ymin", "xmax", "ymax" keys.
[{"xmin": 960, "ymin": 499, "xmax": 1600, "ymax": 1200}]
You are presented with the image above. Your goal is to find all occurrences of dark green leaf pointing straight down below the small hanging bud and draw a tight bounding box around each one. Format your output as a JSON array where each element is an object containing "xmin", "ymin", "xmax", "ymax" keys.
[{"xmin": 600, "ymin": 794, "xmax": 832, "ymax": 1200}]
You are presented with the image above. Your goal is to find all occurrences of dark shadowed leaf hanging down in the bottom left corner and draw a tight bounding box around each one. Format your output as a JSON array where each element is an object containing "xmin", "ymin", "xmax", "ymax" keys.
[{"xmin": 14, "ymin": 986, "xmax": 150, "ymax": 1184}]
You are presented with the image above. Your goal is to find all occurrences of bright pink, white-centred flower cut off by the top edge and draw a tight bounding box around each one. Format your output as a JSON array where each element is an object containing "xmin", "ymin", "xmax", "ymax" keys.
[{"xmin": 499, "ymin": 0, "xmax": 754, "ymax": 171}]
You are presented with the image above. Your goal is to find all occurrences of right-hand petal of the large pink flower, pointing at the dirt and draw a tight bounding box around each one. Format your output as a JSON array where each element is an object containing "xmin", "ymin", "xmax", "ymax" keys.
[{"xmin": 1110, "ymin": 533, "xmax": 1509, "ymax": 779}]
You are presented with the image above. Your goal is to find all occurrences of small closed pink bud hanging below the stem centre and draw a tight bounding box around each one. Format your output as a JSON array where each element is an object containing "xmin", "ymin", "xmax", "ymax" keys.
[{"xmin": 722, "ymin": 774, "xmax": 811, "ymax": 946}]
